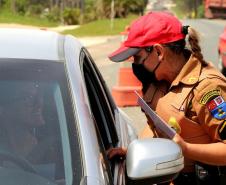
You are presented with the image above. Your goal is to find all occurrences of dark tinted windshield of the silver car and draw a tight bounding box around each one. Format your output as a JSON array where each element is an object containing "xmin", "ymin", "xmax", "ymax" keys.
[{"xmin": 0, "ymin": 61, "xmax": 79, "ymax": 185}]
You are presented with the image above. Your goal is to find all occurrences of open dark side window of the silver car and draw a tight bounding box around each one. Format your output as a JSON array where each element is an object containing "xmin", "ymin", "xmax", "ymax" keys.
[{"xmin": 82, "ymin": 50, "xmax": 118, "ymax": 150}]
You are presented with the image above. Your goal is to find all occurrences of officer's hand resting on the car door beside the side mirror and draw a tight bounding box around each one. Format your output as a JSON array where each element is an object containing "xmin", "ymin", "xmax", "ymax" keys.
[{"xmin": 107, "ymin": 147, "xmax": 127, "ymax": 160}]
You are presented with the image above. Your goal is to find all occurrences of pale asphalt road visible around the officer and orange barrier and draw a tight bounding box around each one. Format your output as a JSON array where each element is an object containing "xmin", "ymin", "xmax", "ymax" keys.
[{"xmin": 88, "ymin": 19, "xmax": 226, "ymax": 134}]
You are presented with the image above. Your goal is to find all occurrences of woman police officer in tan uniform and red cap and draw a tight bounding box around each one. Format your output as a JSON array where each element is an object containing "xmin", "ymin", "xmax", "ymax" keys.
[{"xmin": 109, "ymin": 12, "xmax": 226, "ymax": 185}]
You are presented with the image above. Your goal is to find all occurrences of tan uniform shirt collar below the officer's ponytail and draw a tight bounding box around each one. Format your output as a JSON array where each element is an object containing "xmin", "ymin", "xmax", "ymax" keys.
[{"xmin": 170, "ymin": 54, "xmax": 202, "ymax": 88}]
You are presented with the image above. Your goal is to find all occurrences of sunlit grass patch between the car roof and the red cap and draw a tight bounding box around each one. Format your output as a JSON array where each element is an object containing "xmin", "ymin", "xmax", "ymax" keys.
[{"xmin": 63, "ymin": 15, "xmax": 138, "ymax": 37}]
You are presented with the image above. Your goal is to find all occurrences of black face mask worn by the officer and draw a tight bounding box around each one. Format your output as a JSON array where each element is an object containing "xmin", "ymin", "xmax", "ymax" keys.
[{"xmin": 132, "ymin": 63, "xmax": 157, "ymax": 90}]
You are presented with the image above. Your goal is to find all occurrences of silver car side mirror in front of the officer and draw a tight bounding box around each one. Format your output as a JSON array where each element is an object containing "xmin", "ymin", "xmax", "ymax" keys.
[{"xmin": 126, "ymin": 138, "xmax": 184, "ymax": 185}]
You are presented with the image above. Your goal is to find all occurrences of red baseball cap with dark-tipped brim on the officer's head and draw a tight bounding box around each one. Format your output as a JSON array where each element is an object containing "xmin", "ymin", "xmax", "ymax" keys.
[{"xmin": 108, "ymin": 12, "xmax": 185, "ymax": 62}]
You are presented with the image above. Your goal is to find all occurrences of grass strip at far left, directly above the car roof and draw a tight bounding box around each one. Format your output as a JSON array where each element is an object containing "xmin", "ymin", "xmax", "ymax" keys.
[{"xmin": 0, "ymin": 11, "xmax": 58, "ymax": 27}]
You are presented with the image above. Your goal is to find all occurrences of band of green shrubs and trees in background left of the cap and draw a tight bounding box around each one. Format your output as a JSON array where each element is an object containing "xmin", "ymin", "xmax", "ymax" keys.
[{"xmin": 0, "ymin": 0, "xmax": 147, "ymax": 24}]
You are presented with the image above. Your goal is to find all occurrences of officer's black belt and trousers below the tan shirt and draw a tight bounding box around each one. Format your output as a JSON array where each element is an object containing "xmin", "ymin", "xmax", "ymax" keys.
[{"xmin": 173, "ymin": 163, "xmax": 226, "ymax": 185}]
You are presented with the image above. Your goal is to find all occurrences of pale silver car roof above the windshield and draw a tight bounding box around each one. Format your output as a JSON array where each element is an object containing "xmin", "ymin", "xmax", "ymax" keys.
[{"xmin": 0, "ymin": 28, "xmax": 79, "ymax": 61}]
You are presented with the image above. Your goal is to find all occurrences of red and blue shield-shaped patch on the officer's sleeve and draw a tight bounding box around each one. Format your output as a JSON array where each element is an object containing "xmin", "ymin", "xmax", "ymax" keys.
[{"xmin": 206, "ymin": 96, "xmax": 226, "ymax": 119}]
